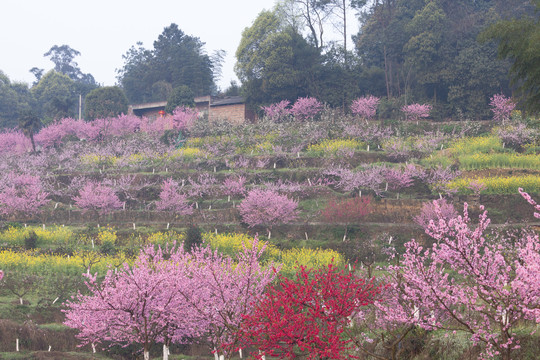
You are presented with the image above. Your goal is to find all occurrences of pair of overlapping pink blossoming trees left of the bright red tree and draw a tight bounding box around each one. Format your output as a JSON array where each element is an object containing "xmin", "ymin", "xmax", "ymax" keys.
[{"xmin": 65, "ymin": 239, "xmax": 275, "ymax": 360}]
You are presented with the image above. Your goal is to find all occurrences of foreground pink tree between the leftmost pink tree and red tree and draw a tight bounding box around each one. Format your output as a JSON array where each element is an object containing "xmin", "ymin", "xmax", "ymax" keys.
[{"xmin": 178, "ymin": 237, "xmax": 279, "ymax": 358}]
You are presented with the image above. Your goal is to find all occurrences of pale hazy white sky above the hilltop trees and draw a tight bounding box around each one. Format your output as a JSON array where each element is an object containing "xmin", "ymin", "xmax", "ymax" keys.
[{"xmin": 0, "ymin": 0, "xmax": 275, "ymax": 88}]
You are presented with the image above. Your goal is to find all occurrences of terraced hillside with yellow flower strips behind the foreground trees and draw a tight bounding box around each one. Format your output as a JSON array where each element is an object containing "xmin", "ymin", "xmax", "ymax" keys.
[{"xmin": 0, "ymin": 111, "xmax": 540, "ymax": 359}]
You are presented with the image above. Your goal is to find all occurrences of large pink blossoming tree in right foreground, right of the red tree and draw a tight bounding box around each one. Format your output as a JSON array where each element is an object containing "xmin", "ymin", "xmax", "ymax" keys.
[{"xmin": 390, "ymin": 195, "xmax": 540, "ymax": 360}]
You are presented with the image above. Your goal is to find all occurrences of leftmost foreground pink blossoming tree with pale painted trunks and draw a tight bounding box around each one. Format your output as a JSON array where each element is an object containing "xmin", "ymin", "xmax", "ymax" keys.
[{"xmin": 64, "ymin": 247, "xmax": 198, "ymax": 360}]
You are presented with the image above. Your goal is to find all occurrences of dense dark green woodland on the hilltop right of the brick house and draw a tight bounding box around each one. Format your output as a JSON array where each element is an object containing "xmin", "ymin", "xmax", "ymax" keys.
[{"xmin": 236, "ymin": 0, "xmax": 540, "ymax": 119}]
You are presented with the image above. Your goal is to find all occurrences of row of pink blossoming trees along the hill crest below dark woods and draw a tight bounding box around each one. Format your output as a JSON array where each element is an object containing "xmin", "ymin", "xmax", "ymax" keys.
[{"xmin": 0, "ymin": 94, "xmax": 516, "ymax": 153}]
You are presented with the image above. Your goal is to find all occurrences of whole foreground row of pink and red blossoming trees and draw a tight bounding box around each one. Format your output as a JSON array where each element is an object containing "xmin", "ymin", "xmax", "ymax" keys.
[{"xmin": 66, "ymin": 190, "xmax": 540, "ymax": 360}]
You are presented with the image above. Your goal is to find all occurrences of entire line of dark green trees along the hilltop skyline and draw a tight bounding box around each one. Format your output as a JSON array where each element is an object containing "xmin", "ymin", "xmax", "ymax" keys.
[{"xmin": 0, "ymin": 0, "xmax": 540, "ymax": 128}]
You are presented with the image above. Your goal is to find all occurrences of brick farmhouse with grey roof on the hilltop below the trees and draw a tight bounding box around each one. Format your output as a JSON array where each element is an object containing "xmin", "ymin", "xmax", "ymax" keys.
[{"xmin": 128, "ymin": 95, "xmax": 256, "ymax": 124}]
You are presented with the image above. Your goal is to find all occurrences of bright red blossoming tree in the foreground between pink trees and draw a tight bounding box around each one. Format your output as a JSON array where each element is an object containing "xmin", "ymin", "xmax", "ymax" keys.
[{"xmin": 241, "ymin": 264, "xmax": 379, "ymax": 359}]
